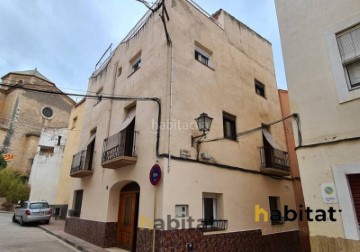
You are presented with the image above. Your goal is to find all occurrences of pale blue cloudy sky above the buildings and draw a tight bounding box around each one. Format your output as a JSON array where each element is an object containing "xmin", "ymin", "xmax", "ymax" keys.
[{"xmin": 0, "ymin": 0, "xmax": 287, "ymax": 100}]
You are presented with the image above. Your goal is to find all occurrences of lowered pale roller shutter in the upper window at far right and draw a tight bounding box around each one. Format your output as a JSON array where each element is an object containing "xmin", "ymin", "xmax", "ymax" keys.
[{"xmin": 337, "ymin": 25, "xmax": 360, "ymax": 62}]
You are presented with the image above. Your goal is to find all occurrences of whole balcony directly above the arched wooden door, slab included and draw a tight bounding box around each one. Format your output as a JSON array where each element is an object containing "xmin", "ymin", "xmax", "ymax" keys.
[{"xmin": 101, "ymin": 129, "xmax": 137, "ymax": 169}]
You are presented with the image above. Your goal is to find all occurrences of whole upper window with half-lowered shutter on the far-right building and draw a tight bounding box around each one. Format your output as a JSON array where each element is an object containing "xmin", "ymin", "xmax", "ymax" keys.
[{"xmin": 337, "ymin": 24, "xmax": 360, "ymax": 90}]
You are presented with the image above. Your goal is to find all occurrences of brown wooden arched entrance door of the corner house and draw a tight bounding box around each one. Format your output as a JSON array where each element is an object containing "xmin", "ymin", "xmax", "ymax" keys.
[{"xmin": 116, "ymin": 182, "xmax": 140, "ymax": 251}]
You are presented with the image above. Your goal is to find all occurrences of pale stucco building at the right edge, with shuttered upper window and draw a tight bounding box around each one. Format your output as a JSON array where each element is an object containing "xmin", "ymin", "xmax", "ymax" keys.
[{"xmin": 276, "ymin": 0, "xmax": 360, "ymax": 251}]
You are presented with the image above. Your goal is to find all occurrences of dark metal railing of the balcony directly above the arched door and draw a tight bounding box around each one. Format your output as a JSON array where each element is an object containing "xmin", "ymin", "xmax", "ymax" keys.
[{"xmin": 102, "ymin": 129, "xmax": 137, "ymax": 163}]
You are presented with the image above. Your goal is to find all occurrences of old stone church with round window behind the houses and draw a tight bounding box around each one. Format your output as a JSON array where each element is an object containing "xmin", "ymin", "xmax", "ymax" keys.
[{"xmin": 0, "ymin": 69, "xmax": 75, "ymax": 175}]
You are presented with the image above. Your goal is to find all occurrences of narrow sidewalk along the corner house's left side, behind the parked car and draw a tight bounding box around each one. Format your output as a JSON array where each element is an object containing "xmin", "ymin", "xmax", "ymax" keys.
[{"xmin": 38, "ymin": 219, "xmax": 126, "ymax": 252}]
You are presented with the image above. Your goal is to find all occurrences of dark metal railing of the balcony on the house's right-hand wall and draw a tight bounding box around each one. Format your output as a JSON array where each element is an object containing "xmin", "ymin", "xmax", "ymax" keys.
[{"xmin": 259, "ymin": 147, "xmax": 290, "ymax": 172}]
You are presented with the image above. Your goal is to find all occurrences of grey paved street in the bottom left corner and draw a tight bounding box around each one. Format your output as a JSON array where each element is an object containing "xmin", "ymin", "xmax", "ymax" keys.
[{"xmin": 0, "ymin": 213, "xmax": 78, "ymax": 252}]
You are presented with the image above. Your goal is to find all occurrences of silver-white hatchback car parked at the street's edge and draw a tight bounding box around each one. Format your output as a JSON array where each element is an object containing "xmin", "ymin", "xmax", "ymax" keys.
[{"xmin": 12, "ymin": 201, "xmax": 52, "ymax": 226}]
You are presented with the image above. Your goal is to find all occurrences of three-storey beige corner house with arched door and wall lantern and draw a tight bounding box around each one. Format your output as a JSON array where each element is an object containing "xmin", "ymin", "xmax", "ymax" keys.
[{"xmin": 65, "ymin": 0, "xmax": 299, "ymax": 251}]
